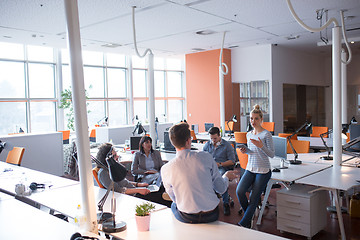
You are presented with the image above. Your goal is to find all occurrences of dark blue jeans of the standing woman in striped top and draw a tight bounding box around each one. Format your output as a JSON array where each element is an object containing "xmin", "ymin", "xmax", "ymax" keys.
[{"xmin": 236, "ymin": 170, "xmax": 271, "ymax": 228}]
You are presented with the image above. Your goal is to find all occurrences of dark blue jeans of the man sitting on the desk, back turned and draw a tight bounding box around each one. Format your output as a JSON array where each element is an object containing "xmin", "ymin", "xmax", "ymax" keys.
[{"xmin": 171, "ymin": 202, "xmax": 219, "ymax": 223}]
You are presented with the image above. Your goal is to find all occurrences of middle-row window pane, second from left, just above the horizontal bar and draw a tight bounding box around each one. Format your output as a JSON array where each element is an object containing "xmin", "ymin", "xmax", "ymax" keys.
[{"xmin": 28, "ymin": 63, "xmax": 55, "ymax": 98}]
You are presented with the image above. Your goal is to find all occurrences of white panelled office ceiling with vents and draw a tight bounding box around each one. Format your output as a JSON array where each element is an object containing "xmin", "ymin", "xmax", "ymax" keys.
[{"xmin": 0, "ymin": 0, "xmax": 360, "ymax": 56}]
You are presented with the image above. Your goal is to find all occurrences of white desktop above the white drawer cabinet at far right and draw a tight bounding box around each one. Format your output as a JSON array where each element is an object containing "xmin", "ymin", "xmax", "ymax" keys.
[{"xmin": 297, "ymin": 166, "xmax": 360, "ymax": 191}]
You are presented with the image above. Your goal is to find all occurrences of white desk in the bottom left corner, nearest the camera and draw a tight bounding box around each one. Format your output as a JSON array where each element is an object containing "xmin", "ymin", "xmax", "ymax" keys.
[{"xmin": 0, "ymin": 199, "xmax": 105, "ymax": 240}]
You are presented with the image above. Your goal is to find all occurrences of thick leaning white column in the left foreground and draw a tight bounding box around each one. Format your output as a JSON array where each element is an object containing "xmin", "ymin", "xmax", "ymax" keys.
[{"xmin": 64, "ymin": 0, "xmax": 97, "ymax": 233}]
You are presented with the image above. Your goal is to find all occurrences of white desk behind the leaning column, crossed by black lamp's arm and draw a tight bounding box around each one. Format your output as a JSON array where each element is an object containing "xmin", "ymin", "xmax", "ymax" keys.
[{"xmin": 28, "ymin": 184, "xmax": 167, "ymax": 220}]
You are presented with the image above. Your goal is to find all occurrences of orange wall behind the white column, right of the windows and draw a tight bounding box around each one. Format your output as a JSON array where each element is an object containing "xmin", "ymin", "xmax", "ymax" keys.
[{"xmin": 185, "ymin": 49, "xmax": 239, "ymax": 132}]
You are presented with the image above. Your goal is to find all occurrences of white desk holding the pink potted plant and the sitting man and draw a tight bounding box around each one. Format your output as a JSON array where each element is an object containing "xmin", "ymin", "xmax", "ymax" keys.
[{"xmin": 112, "ymin": 208, "xmax": 284, "ymax": 240}]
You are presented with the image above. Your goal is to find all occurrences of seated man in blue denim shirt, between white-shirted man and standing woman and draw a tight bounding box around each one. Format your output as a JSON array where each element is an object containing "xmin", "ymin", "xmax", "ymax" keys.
[{"xmin": 203, "ymin": 127, "xmax": 235, "ymax": 216}]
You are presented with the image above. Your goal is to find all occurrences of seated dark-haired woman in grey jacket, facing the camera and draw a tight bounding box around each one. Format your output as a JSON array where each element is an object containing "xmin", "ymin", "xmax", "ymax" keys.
[{"xmin": 131, "ymin": 135, "xmax": 163, "ymax": 184}]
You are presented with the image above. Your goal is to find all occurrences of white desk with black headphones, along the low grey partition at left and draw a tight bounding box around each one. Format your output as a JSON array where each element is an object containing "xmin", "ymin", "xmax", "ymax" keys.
[{"xmin": 0, "ymin": 162, "xmax": 79, "ymax": 196}]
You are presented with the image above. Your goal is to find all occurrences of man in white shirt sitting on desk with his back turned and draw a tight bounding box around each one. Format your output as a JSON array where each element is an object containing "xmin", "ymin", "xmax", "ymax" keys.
[{"xmin": 161, "ymin": 123, "xmax": 235, "ymax": 223}]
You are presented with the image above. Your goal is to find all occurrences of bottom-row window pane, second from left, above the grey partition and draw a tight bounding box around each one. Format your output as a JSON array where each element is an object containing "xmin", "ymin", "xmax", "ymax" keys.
[{"xmin": 30, "ymin": 102, "xmax": 56, "ymax": 132}]
